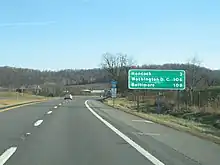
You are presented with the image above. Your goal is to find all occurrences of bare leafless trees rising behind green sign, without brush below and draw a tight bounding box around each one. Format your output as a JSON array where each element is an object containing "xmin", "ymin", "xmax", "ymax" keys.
[{"xmin": 102, "ymin": 53, "xmax": 220, "ymax": 92}]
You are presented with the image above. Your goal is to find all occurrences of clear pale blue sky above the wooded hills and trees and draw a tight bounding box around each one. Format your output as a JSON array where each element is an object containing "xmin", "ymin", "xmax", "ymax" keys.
[{"xmin": 0, "ymin": 0, "xmax": 220, "ymax": 70}]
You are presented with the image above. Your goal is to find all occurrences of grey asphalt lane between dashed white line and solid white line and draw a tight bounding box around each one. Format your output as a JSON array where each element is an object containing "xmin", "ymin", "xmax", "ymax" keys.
[{"xmin": 3, "ymin": 98, "xmax": 161, "ymax": 165}]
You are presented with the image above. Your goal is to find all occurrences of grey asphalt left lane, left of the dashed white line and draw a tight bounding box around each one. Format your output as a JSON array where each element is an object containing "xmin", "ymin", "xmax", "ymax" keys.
[{"xmin": 0, "ymin": 99, "xmax": 63, "ymax": 159}]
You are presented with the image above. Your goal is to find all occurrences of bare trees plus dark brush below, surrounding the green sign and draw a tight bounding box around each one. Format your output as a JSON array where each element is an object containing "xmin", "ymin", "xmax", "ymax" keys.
[{"xmin": 102, "ymin": 53, "xmax": 220, "ymax": 111}]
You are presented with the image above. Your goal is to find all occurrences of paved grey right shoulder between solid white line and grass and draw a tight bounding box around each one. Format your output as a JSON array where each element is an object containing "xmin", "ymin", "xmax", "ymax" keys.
[{"xmin": 90, "ymin": 101, "xmax": 220, "ymax": 165}]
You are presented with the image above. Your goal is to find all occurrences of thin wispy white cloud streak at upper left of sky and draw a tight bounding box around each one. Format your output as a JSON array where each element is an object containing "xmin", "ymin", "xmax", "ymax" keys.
[{"xmin": 0, "ymin": 21, "xmax": 56, "ymax": 27}]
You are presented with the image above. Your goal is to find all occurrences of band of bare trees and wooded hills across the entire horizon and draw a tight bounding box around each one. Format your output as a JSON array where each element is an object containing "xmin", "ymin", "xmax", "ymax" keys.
[{"xmin": 0, "ymin": 53, "xmax": 220, "ymax": 105}]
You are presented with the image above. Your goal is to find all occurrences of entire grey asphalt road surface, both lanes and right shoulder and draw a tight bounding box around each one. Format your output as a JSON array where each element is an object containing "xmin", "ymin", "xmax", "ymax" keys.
[{"xmin": 0, "ymin": 97, "xmax": 220, "ymax": 165}]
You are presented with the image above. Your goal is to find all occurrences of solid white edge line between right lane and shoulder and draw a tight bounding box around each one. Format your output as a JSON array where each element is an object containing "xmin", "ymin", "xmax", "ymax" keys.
[{"xmin": 85, "ymin": 100, "xmax": 165, "ymax": 165}]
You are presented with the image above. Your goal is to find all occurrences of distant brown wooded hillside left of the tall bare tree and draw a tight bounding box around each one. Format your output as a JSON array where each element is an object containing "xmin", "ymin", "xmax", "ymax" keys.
[{"xmin": 0, "ymin": 66, "xmax": 109, "ymax": 88}]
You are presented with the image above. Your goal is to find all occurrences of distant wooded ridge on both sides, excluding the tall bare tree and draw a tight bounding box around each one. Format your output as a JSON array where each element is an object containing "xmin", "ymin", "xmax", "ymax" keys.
[{"xmin": 0, "ymin": 64, "xmax": 220, "ymax": 88}]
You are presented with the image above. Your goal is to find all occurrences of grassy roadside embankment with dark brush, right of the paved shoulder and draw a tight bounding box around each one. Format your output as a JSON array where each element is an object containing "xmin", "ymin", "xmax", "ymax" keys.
[{"xmin": 104, "ymin": 98, "xmax": 220, "ymax": 144}]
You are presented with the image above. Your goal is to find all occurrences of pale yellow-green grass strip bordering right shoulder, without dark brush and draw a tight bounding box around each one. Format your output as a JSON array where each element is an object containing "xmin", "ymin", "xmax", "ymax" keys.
[{"xmin": 104, "ymin": 98, "xmax": 220, "ymax": 144}]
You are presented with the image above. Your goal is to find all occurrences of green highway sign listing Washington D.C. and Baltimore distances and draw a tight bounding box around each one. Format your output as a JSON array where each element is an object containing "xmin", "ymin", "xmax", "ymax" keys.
[{"xmin": 128, "ymin": 69, "xmax": 186, "ymax": 90}]
